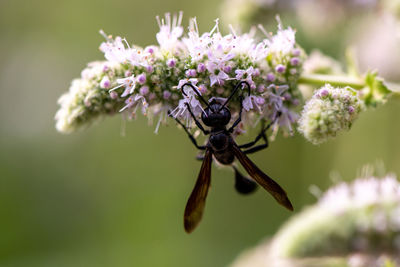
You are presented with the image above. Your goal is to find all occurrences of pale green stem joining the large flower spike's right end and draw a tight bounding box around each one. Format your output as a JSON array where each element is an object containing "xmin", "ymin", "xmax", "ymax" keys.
[{"xmin": 298, "ymin": 74, "xmax": 366, "ymax": 89}]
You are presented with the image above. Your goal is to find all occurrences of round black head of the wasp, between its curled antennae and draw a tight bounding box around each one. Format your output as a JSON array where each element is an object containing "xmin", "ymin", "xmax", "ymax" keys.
[{"xmin": 201, "ymin": 103, "xmax": 231, "ymax": 127}]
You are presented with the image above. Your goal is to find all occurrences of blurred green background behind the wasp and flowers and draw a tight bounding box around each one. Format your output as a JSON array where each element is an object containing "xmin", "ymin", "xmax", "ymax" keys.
[{"xmin": 0, "ymin": 0, "xmax": 400, "ymax": 267}]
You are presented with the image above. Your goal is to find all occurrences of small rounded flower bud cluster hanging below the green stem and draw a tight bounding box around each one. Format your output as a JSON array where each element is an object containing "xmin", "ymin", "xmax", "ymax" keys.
[{"xmin": 298, "ymin": 84, "xmax": 364, "ymax": 145}]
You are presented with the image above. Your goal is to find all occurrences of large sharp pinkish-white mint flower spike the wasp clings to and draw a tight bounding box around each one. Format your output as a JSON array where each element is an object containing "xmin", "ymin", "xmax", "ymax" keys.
[{"xmin": 56, "ymin": 13, "xmax": 305, "ymax": 133}]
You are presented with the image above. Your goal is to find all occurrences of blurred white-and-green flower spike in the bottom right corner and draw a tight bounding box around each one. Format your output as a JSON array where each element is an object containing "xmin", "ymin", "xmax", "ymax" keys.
[{"xmin": 271, "ymin": 175, "xmax": 400, "ymax": 264}]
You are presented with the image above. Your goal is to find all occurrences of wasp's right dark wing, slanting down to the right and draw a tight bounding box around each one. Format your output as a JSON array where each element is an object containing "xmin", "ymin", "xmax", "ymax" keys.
[{"xmin": 232, "ymin": 144, "xmax": 293, "ymax": 210}]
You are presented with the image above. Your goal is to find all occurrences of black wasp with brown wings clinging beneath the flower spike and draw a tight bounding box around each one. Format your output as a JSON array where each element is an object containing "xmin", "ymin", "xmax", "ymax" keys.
[{"xmin": 167, "ymin": 81, "xmax": 293, "ymax": 233}]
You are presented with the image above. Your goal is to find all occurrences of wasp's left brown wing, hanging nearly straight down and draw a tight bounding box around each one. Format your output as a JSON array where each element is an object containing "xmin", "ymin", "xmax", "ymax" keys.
[{"xmin": 184, "ymin": 149, "xmax": 212, "ymax": 233}]
